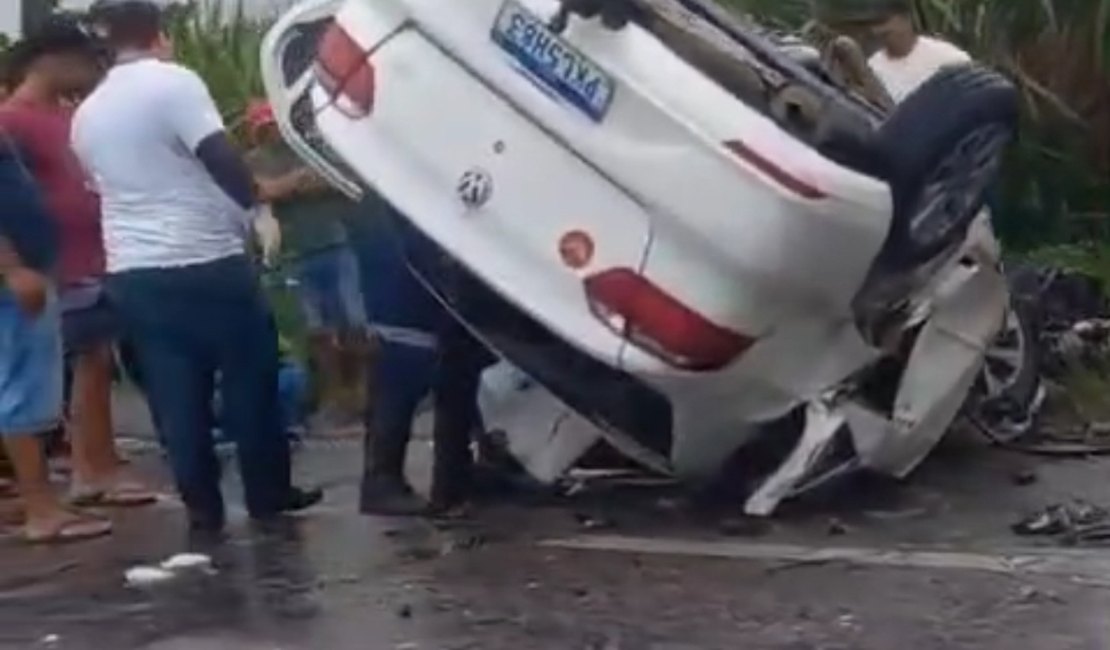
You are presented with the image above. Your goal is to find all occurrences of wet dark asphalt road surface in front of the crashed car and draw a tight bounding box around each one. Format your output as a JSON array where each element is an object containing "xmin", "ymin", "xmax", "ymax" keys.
[{"xmin": 0, "ymin": 388, "xmax": 1110, "ymax": 650}]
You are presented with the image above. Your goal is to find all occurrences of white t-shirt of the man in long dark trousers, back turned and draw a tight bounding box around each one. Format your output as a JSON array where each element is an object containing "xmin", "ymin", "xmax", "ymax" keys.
[{"xmin": 72, "ymin": 59, "xmax": 249, "ymax": 273}]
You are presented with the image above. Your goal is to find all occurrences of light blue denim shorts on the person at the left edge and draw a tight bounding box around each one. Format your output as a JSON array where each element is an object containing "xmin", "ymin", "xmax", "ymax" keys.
[{"xmin": 0, "ymin": 290, "xmax": 62, "ymax": 436}]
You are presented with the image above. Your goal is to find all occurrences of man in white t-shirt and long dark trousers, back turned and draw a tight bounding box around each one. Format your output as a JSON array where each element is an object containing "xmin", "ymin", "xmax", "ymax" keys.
[{"xmin": 72, "ymin": 0, "xmax": 321, "ymax": 529}]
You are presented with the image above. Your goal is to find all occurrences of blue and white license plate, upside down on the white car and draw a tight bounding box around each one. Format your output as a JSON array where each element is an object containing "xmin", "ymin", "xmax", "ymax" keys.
[{"xmin": 493, "ymin": 0, "xmax": 614, "ymax": 122}]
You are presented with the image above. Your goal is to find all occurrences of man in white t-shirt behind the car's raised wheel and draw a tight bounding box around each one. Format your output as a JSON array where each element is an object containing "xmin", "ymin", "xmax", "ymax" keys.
[{"xmin": 869, "ymin": 0, "xmax": 971, "ymax": 104}]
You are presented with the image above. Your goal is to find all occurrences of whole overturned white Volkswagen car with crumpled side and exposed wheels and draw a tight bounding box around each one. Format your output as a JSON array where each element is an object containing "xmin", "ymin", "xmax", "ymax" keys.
[{"xmin": 263, "ymin": 0, "xmax": 1040, "ymax": 515}]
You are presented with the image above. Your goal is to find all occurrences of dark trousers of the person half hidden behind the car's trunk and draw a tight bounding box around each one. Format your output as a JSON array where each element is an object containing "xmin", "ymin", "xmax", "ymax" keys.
[{"xmin": 366, "ymin": 314, "xmax": 492, "ymax": 502}]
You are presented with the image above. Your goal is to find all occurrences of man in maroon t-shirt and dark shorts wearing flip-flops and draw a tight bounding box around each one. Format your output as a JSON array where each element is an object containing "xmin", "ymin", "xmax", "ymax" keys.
[{"xmin": 0, "ymin": 18, "xmax": 154, "ymax": 506}]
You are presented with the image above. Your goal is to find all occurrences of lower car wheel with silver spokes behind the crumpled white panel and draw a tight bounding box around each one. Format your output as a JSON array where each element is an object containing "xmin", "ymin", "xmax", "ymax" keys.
[{"xmin": 969, "ymin": 297, "xmax": 1045, "ymax": 444}]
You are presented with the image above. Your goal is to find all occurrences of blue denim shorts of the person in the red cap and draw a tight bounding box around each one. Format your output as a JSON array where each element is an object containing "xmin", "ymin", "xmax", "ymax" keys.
[{"xmin": 294, "ymin": 246, "xmax": 366, "ymax": 331}]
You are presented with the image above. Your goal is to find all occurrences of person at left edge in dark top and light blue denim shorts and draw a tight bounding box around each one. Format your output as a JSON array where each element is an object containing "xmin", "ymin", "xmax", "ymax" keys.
[{"xmin": 0, "ymin": 133, "xmax": 112, "ymax": 542}]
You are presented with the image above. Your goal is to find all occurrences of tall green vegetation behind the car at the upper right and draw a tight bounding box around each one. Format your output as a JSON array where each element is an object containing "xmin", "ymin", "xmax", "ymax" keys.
[{"xmin": 725, "ymin": 0, "xmax": 1110, "ymax": 268}]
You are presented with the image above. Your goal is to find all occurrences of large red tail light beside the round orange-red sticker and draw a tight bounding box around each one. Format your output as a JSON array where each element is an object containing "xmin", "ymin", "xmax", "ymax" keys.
[{"xmin": 585, "ymin": 268, "xmax": 755, "ymax": 370}]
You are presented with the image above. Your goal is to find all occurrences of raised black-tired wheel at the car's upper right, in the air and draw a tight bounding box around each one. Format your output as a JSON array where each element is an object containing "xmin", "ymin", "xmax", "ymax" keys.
[{"xmin": 877, "ymin": 64, "xmax": 1019, "ymax": 270}]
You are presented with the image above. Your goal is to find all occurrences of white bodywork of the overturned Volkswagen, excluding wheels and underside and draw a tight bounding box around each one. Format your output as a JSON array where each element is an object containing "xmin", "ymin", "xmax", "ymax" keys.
[{"xmin": 263, "ymin": 0, "xmax": 1021, "ymax": 514}]
